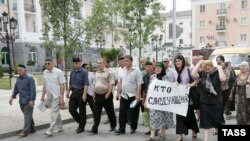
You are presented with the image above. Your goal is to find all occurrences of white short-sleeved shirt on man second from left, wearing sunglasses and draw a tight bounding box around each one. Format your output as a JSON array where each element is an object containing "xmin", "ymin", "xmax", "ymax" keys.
[{"xmin": 43, "ymin": 67, "xmax": 65, "ymax": 99}]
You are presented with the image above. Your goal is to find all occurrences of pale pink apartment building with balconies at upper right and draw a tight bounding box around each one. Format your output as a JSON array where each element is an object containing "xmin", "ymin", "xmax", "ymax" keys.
[{"xmin": 191, "ymin": 0, "xmax": 250, "ymax": 49}]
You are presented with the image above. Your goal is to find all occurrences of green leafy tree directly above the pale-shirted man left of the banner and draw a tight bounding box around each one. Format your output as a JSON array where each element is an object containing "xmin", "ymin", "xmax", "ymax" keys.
[{"xmin": 118, "ymin": 0, "xmax": 164, "ymax": 65}]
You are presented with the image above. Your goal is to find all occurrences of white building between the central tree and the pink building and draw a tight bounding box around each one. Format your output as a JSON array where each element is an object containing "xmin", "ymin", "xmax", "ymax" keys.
[{"xmin": 159, "ymin": 10, "xmax": 193, "ymax": 62}]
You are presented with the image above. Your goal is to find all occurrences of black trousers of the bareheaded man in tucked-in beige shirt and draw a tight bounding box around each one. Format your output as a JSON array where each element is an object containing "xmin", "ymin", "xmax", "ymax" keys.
[{"xmin": 92, "ymin": 94, "xmax": 116, "ymax": 132}]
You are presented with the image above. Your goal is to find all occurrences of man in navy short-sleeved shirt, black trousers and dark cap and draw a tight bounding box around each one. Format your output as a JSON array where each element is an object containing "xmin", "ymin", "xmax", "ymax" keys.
[{"xmin": 67, "ymin": 57, "xmax": 89, "ymax": 134}]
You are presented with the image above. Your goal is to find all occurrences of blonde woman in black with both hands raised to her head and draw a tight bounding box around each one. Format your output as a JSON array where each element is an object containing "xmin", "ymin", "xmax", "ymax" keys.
[{"xmin": 191, "ymin": 60, "xmax": 226, "ymax": 141}]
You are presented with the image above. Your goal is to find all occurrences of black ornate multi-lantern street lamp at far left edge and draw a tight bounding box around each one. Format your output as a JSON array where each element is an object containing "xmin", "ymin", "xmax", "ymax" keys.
[{"xmin": 0, "ymin": 12, "xmax": 17, "ymax": 80}]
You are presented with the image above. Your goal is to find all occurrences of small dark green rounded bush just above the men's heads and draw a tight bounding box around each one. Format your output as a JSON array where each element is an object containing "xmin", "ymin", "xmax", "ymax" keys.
[{"xmin": 100, "ymin": 48, "xmax": 120, "ymax": 62}]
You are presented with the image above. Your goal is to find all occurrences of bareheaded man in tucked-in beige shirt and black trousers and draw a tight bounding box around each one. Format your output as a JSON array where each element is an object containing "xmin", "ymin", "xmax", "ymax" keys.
[{"xmin": 90, "ymin": 59, "xmax": 116, "ymax": 134}]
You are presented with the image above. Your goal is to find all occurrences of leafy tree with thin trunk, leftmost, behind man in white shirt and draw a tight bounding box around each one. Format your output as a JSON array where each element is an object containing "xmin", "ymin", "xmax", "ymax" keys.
[{"xmin": 40, "ymin": 0, "xmax": 84, "ymax": 88}]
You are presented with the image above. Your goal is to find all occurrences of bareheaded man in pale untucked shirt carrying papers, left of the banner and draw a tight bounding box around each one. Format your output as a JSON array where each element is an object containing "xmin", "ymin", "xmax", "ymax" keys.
[{"xmin": 116, "ymin": 55, "xmax": 143, "ymax": 135}]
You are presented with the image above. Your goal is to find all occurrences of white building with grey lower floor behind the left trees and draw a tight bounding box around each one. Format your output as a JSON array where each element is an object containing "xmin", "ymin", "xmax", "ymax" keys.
[{"xmin": 0, "ymin": 0, "xmax": 125, "ymax": 72}]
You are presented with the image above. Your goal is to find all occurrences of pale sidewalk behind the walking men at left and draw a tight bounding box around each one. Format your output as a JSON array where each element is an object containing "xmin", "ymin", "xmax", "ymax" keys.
[{"xmin": 0, "ymin": 86, "xmax": 119, "ymax": 139}]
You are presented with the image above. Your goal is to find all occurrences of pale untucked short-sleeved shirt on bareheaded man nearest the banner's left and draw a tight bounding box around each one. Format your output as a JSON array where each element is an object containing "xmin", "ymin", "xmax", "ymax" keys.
[{"xmin": 119, "ymin": 68, "xmax": 143, "ymax": 99}]
